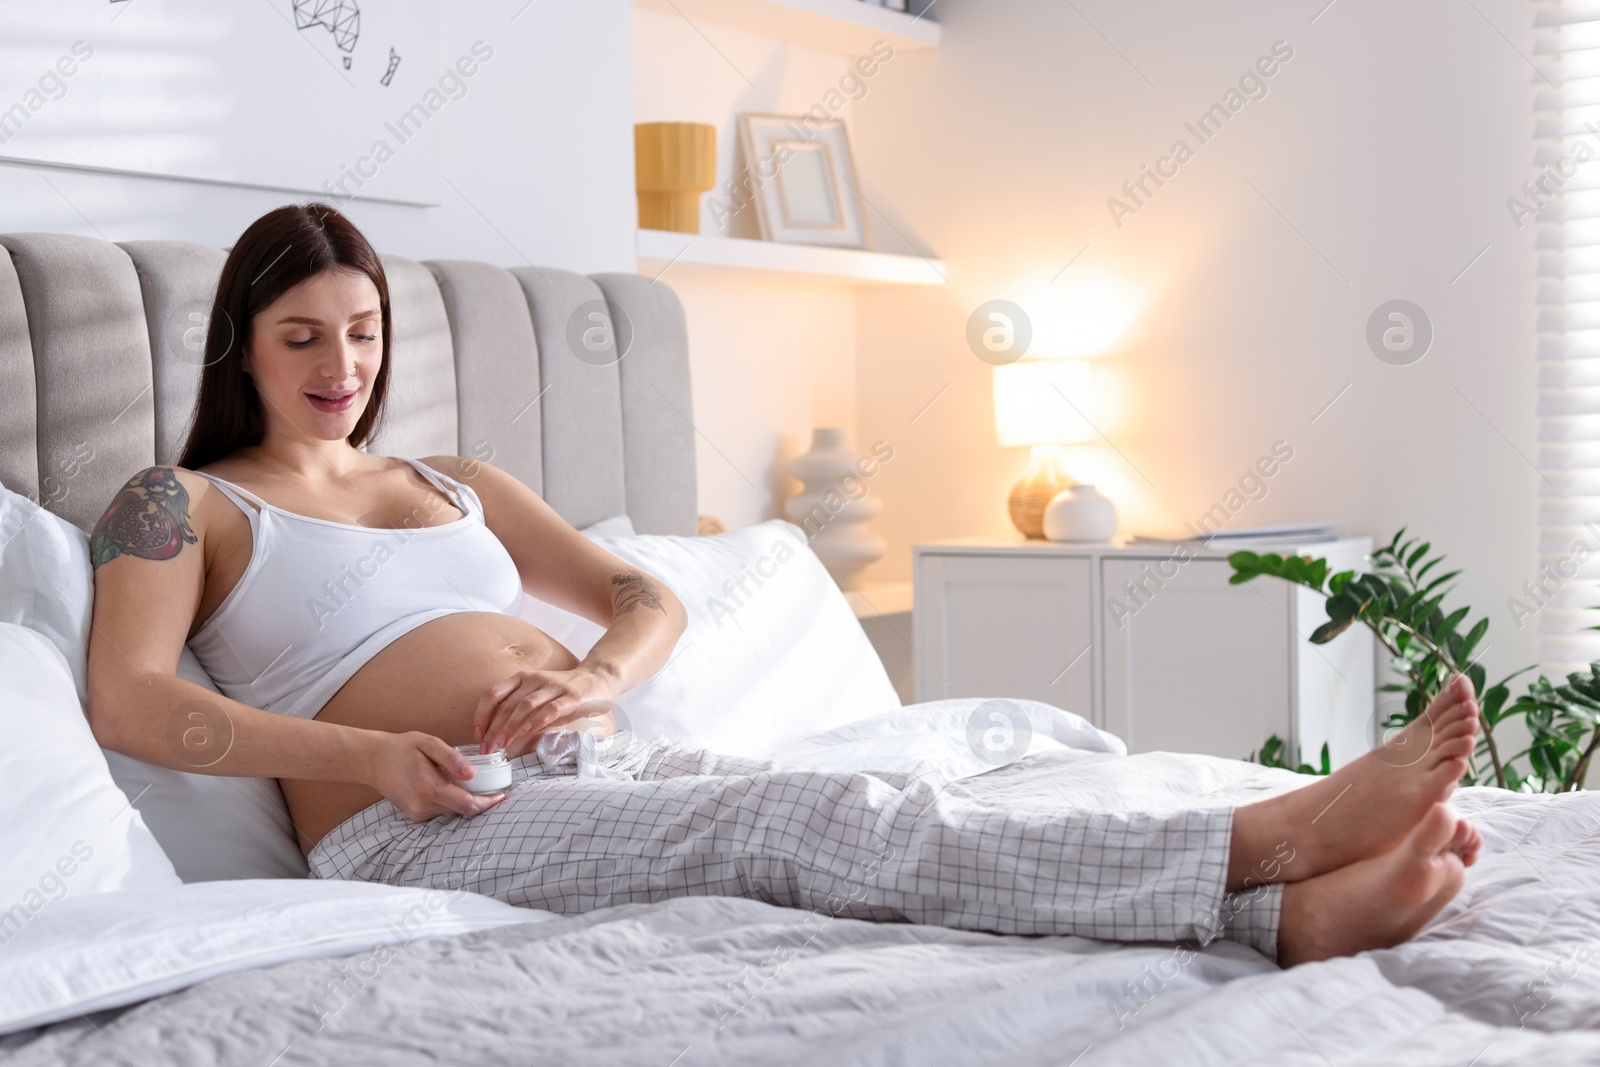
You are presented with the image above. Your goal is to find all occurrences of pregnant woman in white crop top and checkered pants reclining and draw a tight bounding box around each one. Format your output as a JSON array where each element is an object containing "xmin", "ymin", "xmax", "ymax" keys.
[{"xmin": 88, "ymin": 203, "xmax": 1480, "ymax": 966}]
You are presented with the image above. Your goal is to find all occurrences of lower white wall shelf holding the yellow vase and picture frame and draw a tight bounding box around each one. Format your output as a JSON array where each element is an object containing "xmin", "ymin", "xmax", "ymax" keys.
[{"xmin": 638, "ymin": 228, "xmax": 946, "ymax": 288}]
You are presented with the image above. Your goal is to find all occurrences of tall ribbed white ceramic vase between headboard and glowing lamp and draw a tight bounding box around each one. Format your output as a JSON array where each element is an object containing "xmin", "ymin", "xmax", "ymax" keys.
[{"xmin": 784, "ymin": 426, "xmax": 888, "ymax": 589}]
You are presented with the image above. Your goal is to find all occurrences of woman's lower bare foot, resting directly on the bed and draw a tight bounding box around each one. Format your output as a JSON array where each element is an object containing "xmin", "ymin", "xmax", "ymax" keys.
[{"xmin": 1278, "ymin": 805, "xmax": 1478, "ymax": 968}]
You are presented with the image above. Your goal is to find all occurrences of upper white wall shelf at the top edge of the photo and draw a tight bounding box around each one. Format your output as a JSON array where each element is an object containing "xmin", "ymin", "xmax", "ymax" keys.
[{"xmin": 634, "ymin": 0, "xmax": 939, "ymax": 54}]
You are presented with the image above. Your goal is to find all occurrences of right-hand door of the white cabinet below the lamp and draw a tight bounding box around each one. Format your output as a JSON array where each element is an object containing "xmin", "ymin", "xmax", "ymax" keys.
[{"xmin": 1101, "ymin": 560, "xmax": 1294, "ymax": 760}]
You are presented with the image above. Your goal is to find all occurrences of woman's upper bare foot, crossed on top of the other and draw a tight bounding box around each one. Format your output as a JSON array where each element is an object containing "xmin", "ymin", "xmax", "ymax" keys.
[{"xmin": 1227, "ymin": 675, "xmax": 1478, "ymax": 889}]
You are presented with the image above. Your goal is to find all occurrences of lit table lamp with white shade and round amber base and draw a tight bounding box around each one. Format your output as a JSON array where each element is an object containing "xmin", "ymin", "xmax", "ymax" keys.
[{"xmin": 994, "ymin": 360, "xmax": 1094, "ymax": 537}]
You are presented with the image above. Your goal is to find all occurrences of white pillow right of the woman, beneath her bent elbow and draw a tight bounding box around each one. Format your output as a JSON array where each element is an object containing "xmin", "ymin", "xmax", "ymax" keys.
[{"xmin": 520, "ymin": 518, "xmax": 901, "ymax": 758}]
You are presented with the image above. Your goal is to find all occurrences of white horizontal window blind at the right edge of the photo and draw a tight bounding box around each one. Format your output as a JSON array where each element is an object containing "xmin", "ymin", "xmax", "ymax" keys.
[{"xmin": 1529, "ymin": 0, "xmax": 1600, "ymax": 677}]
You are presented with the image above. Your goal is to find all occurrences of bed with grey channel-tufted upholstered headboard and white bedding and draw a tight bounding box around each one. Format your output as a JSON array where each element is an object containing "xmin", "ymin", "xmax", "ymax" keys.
[{"xmin": 0, "ymin": 234, "xmax": 1600, "ymax": 1067}]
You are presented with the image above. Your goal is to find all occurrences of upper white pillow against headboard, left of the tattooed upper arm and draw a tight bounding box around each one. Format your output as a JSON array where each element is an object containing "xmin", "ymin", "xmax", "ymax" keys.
[{"xmin": 0, "ymin": 485, "xmax": 94, "ymax": 705}]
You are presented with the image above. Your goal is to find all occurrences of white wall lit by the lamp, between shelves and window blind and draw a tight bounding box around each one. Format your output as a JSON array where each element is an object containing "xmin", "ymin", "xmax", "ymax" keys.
[{"xmin": 854, "ymin": 0, "xmax": 1539, "ymax": 694}]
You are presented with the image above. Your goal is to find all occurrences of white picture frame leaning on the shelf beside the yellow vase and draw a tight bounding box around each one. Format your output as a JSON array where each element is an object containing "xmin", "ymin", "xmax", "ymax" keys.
[{"xmin": 739, "ymin": 112, "xmax": 872, "ymax": 248}]
